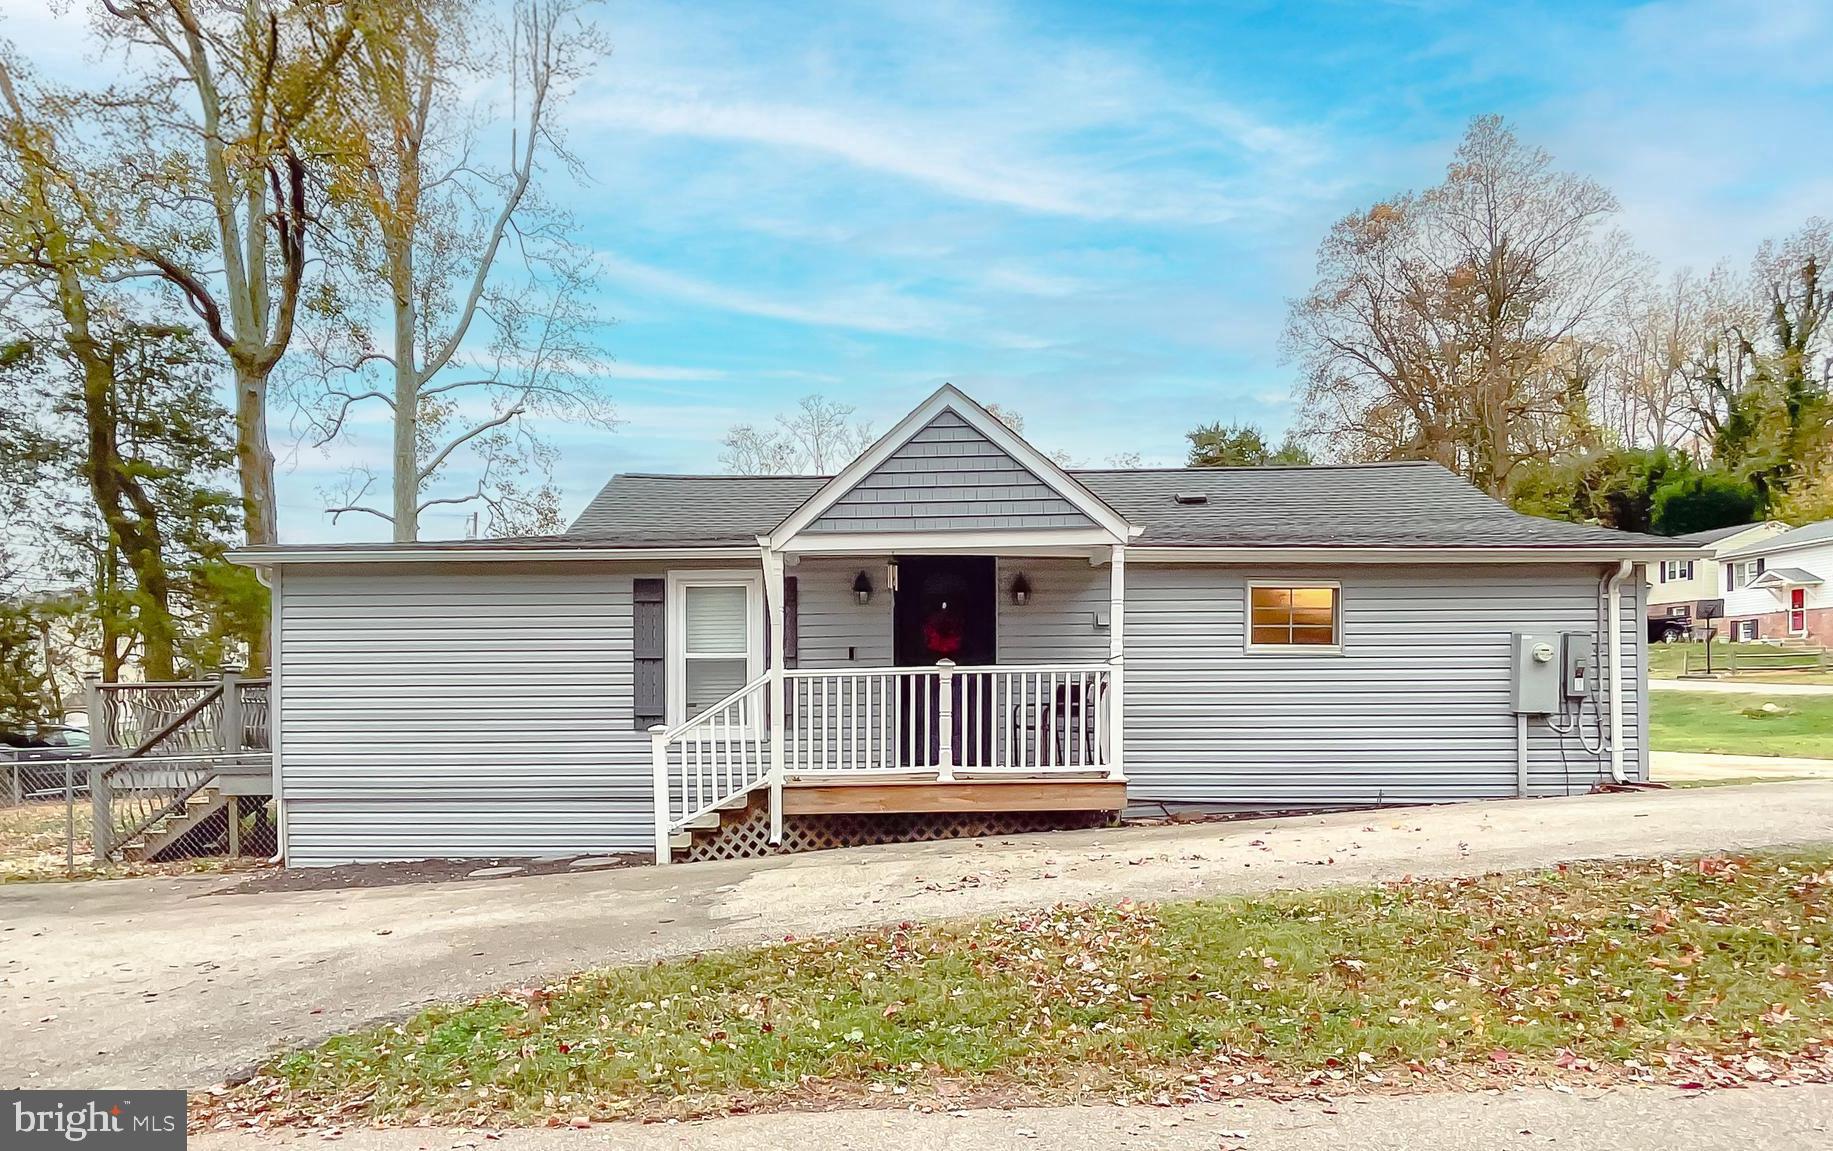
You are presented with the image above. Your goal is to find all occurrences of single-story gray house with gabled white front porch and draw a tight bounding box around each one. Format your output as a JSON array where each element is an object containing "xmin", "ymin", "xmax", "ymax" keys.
[{"xmin": 236, "ymin": 387, "xmax": 1701, "ymax": 865}]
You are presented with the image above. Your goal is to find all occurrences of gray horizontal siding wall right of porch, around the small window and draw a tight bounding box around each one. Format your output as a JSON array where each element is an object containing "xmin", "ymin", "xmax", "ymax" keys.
[{"xmin": 1125, "ymin": 563, "xmax": 1646, "ymax": 808}]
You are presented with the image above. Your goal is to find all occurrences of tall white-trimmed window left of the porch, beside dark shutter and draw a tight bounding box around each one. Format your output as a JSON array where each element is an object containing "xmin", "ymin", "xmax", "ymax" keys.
[{"xmin": 667, "ymin": 572, "xmax": 764, "ymax": 724}]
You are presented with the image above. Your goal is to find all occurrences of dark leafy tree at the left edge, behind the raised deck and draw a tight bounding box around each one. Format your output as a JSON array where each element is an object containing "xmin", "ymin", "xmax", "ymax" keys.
[{"xmin": 0, "ymin": 320, "xmax": 266, "ymax": 678}]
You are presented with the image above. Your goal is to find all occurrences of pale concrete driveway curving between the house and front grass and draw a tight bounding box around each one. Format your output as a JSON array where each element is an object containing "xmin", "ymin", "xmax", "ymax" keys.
[{"xmin": 0, "ymin": 781, "xmax": 1833, "ymax": 1087}]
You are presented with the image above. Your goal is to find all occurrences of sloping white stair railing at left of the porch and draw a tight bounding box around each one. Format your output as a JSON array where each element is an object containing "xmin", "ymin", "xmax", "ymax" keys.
[{"xmin": 649, "ymin": 673, "xmax": 770, "ymax": 863}]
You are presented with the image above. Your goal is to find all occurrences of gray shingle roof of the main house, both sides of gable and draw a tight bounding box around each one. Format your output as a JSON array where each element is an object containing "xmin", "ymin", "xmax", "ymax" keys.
[{"xmin": 566, "ymin": 462, "xmax": 1675, "ymax": 548}]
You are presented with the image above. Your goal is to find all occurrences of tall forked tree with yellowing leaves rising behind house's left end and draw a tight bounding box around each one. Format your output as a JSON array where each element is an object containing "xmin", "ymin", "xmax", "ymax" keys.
[{"xmin": 77, "ymin": 0, "xmax": 362, "ymax": 544}]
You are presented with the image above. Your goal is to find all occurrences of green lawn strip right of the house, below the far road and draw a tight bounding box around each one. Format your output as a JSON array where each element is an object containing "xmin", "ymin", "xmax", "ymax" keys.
[{"xmin": 1648, "ymin": 691, "xmax": 1833, "ymax": 759}]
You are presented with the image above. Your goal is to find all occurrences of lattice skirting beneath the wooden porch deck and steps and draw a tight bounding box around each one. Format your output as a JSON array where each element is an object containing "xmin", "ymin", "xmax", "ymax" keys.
[{"xmin": 675, "ymin": 799, "xmax": 1120, "ymax": 863}]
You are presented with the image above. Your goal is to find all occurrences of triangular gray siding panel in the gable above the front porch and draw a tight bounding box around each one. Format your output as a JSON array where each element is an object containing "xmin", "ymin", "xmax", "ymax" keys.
[{"xmin": 807, "ymin": 409, "xmax": 1092, "ymax": 532}]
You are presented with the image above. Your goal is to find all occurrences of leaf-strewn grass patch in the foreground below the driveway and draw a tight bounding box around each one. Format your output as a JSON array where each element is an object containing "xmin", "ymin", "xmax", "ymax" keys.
[{"xmin": 221, "ymin": 849, "xmax": 1833, "ymax": 1124}]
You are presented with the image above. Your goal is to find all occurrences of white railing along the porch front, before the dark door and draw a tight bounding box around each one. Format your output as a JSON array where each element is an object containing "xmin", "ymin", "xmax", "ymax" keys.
[{"xmin": 783, "ymin": 663, "xmax": 1111, "ymax": 781}]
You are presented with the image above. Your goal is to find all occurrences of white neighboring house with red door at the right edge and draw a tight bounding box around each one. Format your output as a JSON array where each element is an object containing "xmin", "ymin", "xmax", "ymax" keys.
[{"xmin": 1719, "ymin": 521, "xmax": 1833, "ymax": 647}]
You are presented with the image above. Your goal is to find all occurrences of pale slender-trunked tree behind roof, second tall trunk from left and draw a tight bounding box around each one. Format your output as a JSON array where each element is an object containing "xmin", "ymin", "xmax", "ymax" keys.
[{"xmin": 306, "ymin": 0, "xmax": 616, "ymax": 541}]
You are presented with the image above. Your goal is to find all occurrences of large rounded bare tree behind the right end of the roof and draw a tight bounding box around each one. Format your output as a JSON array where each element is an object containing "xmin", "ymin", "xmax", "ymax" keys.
[{"xmin": 1287, "ymin": 117, "xmax": 1635, "ymax": 493}]
